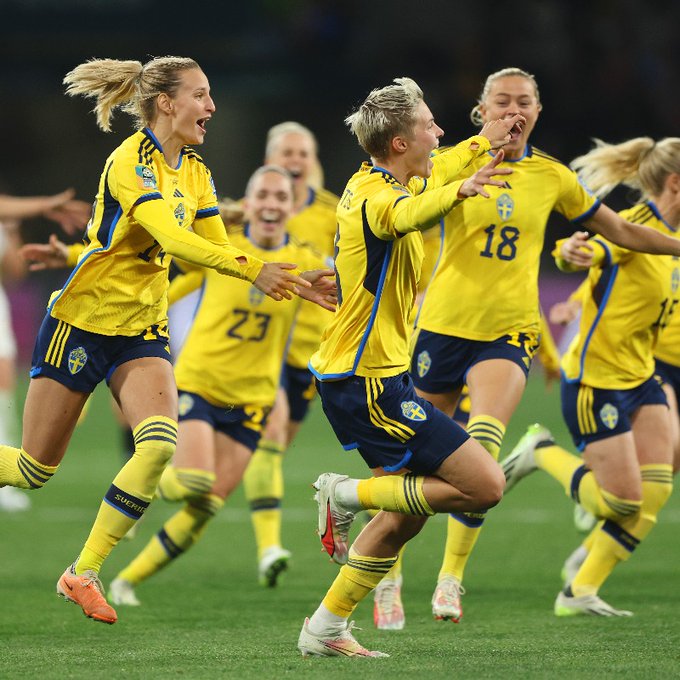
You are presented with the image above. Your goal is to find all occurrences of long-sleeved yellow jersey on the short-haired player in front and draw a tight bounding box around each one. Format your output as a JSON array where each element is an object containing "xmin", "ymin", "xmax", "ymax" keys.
[{"xmin": 310, "ymin": 137, "xmax": 489, "ymax": 380}]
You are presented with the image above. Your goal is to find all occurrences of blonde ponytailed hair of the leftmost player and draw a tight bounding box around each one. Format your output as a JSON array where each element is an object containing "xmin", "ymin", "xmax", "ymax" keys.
[{"xmin": 64, "ymin": 57, "xmax": 200, "ymax": 132}]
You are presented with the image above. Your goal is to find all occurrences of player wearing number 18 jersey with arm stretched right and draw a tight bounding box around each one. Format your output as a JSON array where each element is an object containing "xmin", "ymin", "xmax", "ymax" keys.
[{"xmin": 411, "ymin": 68, "xmax": 679, "ymax": 621}]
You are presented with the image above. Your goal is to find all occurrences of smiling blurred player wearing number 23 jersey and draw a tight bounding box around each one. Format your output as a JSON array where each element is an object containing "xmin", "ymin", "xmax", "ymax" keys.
[{"xmin": 110, "ymin": 165, "xmax": 335, "ymax": 605}]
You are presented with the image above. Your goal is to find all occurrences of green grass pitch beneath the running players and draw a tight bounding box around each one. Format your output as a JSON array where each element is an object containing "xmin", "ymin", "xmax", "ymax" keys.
[{"xmin": 0, "ymin": 377, "xmax": 680, "ymax": 680}]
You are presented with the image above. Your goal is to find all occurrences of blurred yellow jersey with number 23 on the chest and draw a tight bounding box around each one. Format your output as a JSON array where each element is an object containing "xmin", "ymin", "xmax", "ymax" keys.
[{"xmin": 173, "ymin": 225, "xmax": 320, "ymax": 407}]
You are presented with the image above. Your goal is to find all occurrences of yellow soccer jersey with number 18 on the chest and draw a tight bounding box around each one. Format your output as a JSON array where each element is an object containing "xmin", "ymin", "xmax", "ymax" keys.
[{"xmin": 418, "ymin": 146, "xmax": 599, "ymax": 341}]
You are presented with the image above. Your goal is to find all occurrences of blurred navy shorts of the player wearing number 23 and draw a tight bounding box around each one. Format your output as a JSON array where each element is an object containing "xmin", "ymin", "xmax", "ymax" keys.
[{"xmin": 178, "ymin": 389, "xmax": 271, "ymax": 451}]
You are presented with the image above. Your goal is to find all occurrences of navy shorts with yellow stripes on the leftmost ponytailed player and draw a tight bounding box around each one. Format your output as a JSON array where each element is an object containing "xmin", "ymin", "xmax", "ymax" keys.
[{"xmin": 30, "ymin": 314, "xmax": 170, "ymax": 392}]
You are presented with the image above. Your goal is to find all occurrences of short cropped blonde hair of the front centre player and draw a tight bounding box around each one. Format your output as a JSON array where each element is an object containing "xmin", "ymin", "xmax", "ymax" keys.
[{"xmin": 345, "ymin": 78, "xmax": 423, "ymax": 160}]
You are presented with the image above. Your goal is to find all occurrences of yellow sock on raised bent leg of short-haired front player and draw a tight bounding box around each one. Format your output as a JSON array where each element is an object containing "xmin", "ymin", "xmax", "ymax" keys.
[{"xmin": 357, "ymin": 474, "xmax": 434, "ymax": 516}]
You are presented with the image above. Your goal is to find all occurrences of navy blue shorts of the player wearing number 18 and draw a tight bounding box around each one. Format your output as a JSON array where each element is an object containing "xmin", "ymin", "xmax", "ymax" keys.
[{"xmin": 411, "ymin": 330, "xmax": 540, "ymax": 394}]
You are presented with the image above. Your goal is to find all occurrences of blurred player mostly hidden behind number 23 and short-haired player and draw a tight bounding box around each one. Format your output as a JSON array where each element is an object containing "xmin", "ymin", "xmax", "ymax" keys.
[{"xmin": 243, "ymin": 121, "xmax": 338, "ymax": 587}]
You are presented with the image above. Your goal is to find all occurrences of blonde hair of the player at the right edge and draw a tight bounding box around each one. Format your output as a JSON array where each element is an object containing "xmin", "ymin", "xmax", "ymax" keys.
[{"xmin": 571, "ymin": 137, "xmax": 680, "ymax": 198}]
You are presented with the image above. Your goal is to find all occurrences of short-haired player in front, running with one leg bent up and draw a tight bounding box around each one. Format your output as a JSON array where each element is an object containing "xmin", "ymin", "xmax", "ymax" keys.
[{"xmin": 298, "ymin": 78, "xmax": 524, "ymax": 656}]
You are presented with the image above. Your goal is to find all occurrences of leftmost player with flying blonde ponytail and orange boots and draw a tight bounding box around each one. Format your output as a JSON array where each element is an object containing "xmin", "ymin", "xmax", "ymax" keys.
[{"xmin": 0, "ymin": 57, "xmax": 330, "ymax": 623}]
